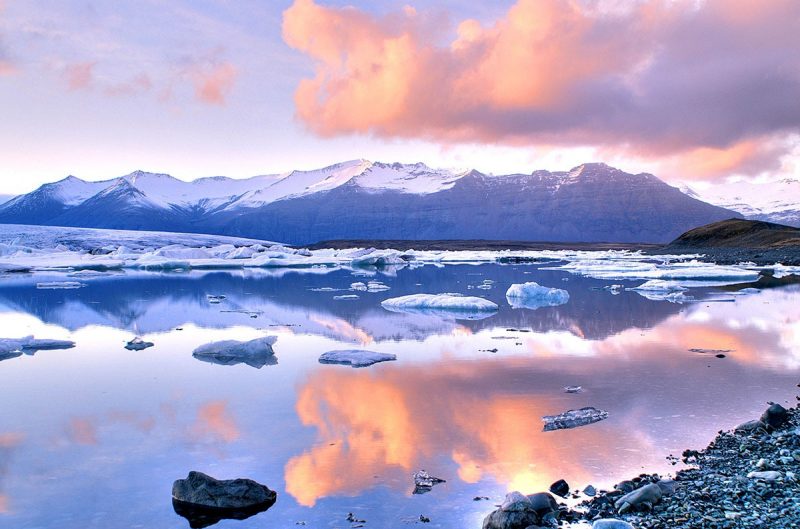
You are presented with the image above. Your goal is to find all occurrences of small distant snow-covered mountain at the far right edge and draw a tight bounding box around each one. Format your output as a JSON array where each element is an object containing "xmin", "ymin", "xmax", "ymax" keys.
[{"xmin": 680, "ymin": 178, "xmax": 800, "ymax": 228}]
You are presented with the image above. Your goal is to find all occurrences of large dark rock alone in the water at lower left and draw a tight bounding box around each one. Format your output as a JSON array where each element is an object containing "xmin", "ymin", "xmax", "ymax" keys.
[{"xmin": 172, "ymin": 471, "xmax": 277, "ymax": 529}]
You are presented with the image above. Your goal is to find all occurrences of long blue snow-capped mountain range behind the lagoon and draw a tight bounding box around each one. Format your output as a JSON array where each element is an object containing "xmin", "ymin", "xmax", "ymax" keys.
[{"xmin": 0, "ymin": 160, "xmax": 736, "ymax": 244}]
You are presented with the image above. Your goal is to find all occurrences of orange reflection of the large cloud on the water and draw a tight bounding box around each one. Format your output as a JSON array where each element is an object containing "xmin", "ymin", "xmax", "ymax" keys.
[{"xmin": 284, "ymin": 362, "xmax": 644, "ymax": 506}]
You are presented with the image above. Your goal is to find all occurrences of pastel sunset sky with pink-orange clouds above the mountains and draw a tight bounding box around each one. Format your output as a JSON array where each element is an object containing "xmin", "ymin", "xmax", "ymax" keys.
[{"xmin": 0, "ymin": 0, "xmax": 800, "ymax": 194}]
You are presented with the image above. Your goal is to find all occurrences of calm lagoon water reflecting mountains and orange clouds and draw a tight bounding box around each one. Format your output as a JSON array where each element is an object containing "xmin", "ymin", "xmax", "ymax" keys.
[{"xmin": 0, "ymin": 265, "xmax": 800, "ymax": 529}]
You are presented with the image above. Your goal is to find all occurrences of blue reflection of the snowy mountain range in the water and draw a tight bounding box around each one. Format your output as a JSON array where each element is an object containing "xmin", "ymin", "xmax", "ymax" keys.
[{"xmin": 0, "ymin": 265, "xmax": 681, "ymax": 344}]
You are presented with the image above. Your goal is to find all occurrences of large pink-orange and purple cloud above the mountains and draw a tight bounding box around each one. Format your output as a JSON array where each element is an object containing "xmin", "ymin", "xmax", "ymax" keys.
[{"xmin": 283, "ymin": 0, "xmax": 800, "ymax": 175}]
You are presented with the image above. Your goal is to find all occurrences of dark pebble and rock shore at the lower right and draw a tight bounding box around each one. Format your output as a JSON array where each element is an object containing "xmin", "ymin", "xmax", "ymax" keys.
[{"xmin": 483, "ymin": 404, "xmax": 800, "ymax": 529}]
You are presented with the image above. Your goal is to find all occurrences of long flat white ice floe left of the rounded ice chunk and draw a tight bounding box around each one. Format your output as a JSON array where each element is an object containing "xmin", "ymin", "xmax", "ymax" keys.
[{"xmin": 381, "ymin": 293, "xmax": 498, "ymax": 319}]
